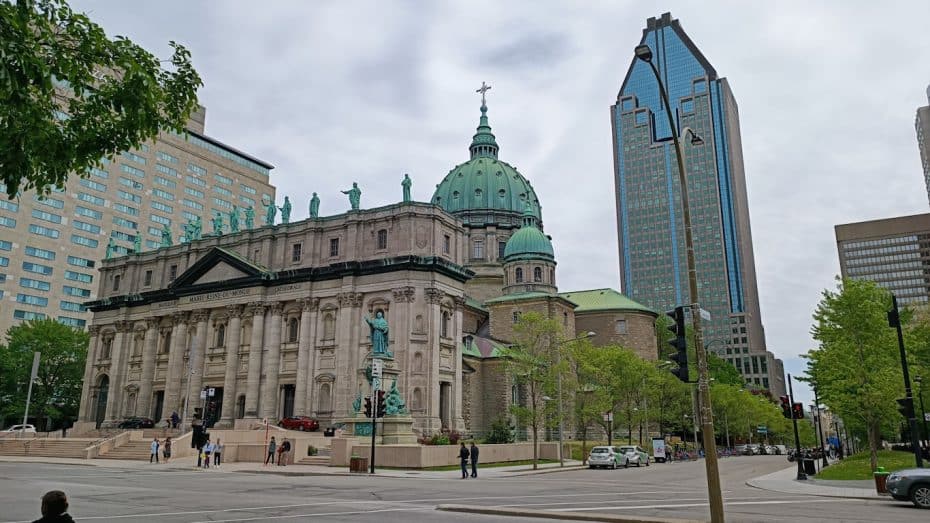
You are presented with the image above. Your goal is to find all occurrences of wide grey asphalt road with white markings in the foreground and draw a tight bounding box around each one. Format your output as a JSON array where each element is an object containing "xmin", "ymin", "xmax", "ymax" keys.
[{"xmin": 0, "ymin": 456, "xmax": 930, "ymax": 523}]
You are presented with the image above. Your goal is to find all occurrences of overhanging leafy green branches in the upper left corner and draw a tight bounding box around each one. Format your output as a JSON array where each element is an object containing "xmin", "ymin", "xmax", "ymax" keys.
[{"xmin": 0, "ymin": 0, "xmax": 203, "ymax": 198}]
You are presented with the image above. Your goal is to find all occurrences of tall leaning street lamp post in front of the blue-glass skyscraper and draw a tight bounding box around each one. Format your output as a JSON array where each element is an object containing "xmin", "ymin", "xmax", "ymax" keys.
[{"xmin": 634, "ymin": 44, "xmax": 724, "ymax": 523}]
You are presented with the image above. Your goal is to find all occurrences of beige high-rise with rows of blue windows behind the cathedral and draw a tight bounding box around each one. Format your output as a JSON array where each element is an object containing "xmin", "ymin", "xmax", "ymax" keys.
[{"xmin": 0, "ymin": 108, "xmax": 275, "ymax": 336}]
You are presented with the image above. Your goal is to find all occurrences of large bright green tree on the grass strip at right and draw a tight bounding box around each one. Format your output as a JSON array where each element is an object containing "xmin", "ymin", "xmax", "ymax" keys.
[{"xmin": 806, "ymin": 279, "xmax": 903, "ymax": 470}]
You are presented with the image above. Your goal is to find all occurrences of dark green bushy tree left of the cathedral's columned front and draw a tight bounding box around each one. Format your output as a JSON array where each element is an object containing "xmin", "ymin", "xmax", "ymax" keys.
[{"xmin": 0, "ymin": 319, "xmax": 90, "ymax": 430}]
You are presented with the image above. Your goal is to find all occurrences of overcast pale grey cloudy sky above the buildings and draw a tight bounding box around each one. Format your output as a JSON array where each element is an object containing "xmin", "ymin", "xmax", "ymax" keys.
[{"xmin": 71, "ymin": 0, "xmax": 930, "ymax": 403}]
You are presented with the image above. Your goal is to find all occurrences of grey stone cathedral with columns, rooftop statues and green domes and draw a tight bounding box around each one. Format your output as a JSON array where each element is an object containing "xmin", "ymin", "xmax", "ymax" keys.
[{"xmin": 75, "ymin": 88, "xmax": 658, "ymax": 435}]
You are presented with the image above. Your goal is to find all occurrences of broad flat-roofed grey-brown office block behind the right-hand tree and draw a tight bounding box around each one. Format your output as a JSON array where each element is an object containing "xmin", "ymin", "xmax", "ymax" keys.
[{"xmin": 834, "ymin": 214, "xmax": 930, "ymax": 305}]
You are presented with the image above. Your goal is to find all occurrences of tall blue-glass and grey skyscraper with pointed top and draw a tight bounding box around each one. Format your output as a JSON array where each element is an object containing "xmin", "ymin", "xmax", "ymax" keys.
[{"xmin": 611, "ymin": 13, "xmax": 784, "ymax": 393}]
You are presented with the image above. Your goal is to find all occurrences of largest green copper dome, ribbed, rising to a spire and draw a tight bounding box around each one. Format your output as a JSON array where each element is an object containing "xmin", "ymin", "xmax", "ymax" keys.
[{"xmin": 432, "ymin": 103, "xmax": 542, "ymax": 221}]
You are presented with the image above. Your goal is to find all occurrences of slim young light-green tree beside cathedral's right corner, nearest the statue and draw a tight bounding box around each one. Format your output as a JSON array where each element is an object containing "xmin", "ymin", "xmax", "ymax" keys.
[{"xmin": 504, "ymin": 312, "xmax": 568, "ymax": 469}]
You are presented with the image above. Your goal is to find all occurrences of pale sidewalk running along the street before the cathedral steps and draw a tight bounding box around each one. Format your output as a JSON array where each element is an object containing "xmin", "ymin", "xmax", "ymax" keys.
[{"xmin": 0, "ymin": 456, "xmax": 582, "ymax": 479}]
